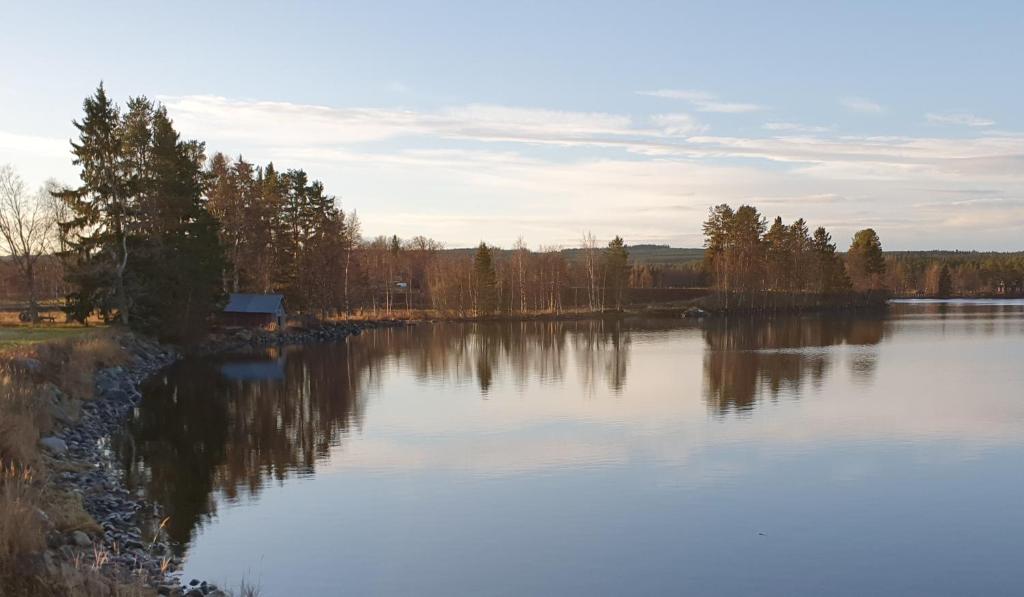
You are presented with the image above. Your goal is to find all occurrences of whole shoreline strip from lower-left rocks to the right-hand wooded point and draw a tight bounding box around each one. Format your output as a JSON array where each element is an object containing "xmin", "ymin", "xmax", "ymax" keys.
[{"xmin": 14, "ymin": 297, "xmax": 1005, "ymax": 597}]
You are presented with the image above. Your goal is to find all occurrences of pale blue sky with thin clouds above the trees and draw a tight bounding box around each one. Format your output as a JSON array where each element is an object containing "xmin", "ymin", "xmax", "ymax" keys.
[{"xmin": 0, "ymin": 0, "xmax": 1024, "ymax": 250}]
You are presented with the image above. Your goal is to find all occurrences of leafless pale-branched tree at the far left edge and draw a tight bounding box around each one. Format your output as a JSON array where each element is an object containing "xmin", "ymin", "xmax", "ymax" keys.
[{"xmin": 0, "ymin": 165, "xmax": 53, "ymax": 323}]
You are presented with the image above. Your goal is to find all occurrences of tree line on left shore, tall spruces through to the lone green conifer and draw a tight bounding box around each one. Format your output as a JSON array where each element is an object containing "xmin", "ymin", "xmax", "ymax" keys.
[{"xmin": 0, "ymin": 84, "xmax": 643, "ymax": 339}]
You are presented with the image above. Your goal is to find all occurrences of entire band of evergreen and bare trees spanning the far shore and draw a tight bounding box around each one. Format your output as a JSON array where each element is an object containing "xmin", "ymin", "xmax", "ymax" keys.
[{"xmin": 0, "ymin": 84, "xmax": 1024, "ymax": 339}]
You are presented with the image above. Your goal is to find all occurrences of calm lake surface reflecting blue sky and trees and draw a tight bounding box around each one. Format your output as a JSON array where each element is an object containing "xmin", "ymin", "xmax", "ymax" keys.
[{"xmin": 124, "ymin": 302, "xmax": 1024, "ymax": 596}]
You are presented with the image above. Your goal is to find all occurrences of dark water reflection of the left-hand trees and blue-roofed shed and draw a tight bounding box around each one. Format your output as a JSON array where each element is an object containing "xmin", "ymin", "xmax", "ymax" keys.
[{"xmin": 120, "ymin": 322, "xmax": 630, "ymax": 554}]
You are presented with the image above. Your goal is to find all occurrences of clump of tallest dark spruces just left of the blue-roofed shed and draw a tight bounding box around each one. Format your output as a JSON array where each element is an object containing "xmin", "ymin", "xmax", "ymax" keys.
[{"xmin": 57, "ymin": 86, "xmax": 223, "ymax": 340}]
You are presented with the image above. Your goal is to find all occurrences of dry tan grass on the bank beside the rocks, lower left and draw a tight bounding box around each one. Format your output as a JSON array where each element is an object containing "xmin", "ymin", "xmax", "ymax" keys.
[{"xmin": 0, "ymin": 331, "xmax": 148, "ymax": 597}]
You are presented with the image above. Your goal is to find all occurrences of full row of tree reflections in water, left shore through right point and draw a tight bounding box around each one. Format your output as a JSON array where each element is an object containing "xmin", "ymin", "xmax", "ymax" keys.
[{"xmin": 122, "ymin": 318, "xmax": 883, "ymax": 548}]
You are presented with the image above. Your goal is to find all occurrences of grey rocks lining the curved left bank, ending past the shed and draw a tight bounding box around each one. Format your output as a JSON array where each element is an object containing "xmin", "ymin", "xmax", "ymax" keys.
[{"xmin": 36, "ymin": 322, "xmax": 409, "ymax": 597}]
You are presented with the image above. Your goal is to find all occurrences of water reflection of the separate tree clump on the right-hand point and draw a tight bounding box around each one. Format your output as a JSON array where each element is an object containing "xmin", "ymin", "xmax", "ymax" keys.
[{"xmin": 703, "ymin": 317, "xmax": 885, "ymax": 415}]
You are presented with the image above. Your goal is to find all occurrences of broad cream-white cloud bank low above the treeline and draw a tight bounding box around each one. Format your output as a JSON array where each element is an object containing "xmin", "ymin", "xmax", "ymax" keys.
[{"xmin": 146, "ymin": 92, "xmax": 1024, "ymax": 248}]
